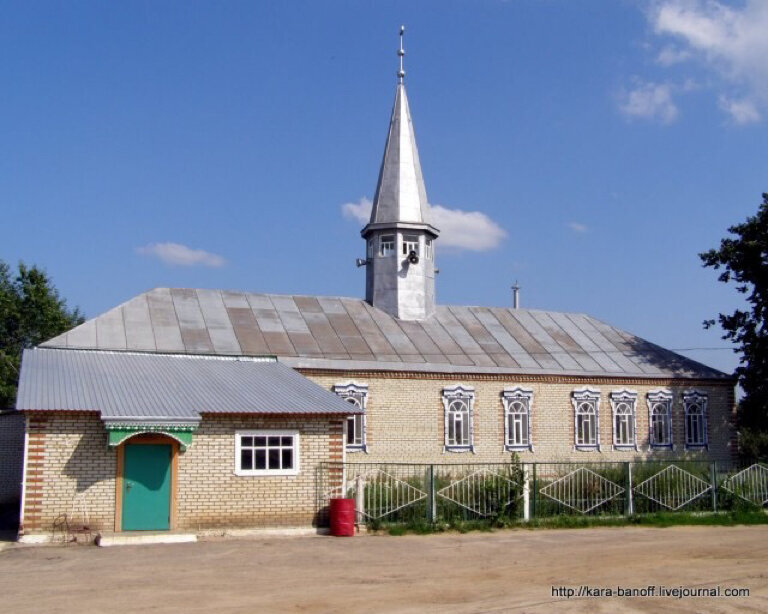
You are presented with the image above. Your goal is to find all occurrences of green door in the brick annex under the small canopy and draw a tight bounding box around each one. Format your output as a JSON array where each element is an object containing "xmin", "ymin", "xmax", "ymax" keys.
[{"xmin": 122, "ymin": 444, "xmax": 171, "ymax": 531}]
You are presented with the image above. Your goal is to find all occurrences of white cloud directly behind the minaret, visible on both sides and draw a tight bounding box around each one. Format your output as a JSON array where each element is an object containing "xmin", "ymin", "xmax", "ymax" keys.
[{"xmin": 341, "ymin": 198, "xmax": 507, "ymax": 252}]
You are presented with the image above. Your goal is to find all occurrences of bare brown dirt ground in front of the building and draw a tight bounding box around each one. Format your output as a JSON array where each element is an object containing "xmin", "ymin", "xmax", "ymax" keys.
[{"xmin": 0, "ymin": 526, "xmax": 768, "ymax": 614}]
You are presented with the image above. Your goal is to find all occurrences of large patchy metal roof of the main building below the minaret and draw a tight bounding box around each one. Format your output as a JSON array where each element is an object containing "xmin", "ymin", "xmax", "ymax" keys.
[{"xmin": 43, "ymin": 288, "xmax": 729, "ymax": 379}]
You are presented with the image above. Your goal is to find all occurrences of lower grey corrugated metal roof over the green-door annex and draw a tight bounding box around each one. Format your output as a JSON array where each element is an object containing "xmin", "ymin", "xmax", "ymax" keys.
[{"xmin": 16, "ymin": 348, "xmax": 364, "ymax": 420}]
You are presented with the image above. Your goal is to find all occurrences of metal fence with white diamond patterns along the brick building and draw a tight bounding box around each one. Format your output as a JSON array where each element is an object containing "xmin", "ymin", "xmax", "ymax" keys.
[{"xmin": 317, "ymin": 460, "xmax": 768, "ymax": 525}]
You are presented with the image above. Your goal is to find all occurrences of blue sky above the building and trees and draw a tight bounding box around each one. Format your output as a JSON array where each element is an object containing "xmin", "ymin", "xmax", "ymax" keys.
[{"xmin": 0, "ymin": 0, "xmax": 768, "ymax": 371}]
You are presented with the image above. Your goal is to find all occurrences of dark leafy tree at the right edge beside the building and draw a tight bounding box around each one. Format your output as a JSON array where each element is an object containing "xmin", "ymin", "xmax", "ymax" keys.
[{"xmin": 699, "ymin": 194, "xmax": 768, "ymax": 459}]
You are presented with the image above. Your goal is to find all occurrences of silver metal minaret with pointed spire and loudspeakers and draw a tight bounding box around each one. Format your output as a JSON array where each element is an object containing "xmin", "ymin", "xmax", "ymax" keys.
[{"xmin": 360, "ymin": 26, "xmax": 439, "ymax": 320}]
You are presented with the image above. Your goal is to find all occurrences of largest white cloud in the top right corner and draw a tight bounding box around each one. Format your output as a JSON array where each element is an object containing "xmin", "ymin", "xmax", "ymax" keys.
[{"xmin": 649, "ymin": 0, "xmax": 768, "ymax": 124}]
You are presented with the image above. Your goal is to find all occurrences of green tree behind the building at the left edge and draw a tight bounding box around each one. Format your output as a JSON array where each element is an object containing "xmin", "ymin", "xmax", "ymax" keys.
[{"xmin": 0, "ymin": 260, "xmax": 84, "ymax": 409}]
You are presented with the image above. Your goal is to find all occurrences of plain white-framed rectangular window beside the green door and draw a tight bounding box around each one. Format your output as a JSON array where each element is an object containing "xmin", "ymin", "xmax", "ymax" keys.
[{"xmin": 235, "ymin": 431, "xmax": 299, "ymax": 476}]
